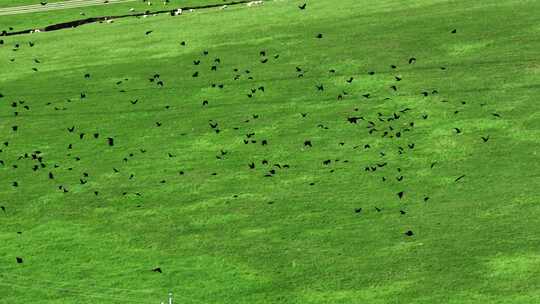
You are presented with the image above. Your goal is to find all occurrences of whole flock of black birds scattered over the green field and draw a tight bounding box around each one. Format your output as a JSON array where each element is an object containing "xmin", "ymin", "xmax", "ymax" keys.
[{"xmin": 0, "ymin": 2, "xmax": 501, "ymax": 273}]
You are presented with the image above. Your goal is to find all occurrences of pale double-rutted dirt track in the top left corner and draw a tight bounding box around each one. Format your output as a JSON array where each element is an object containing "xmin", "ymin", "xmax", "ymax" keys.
[{"xmin": 0, "ymin": 0, "xmax": 137, "ymax": 16}]
